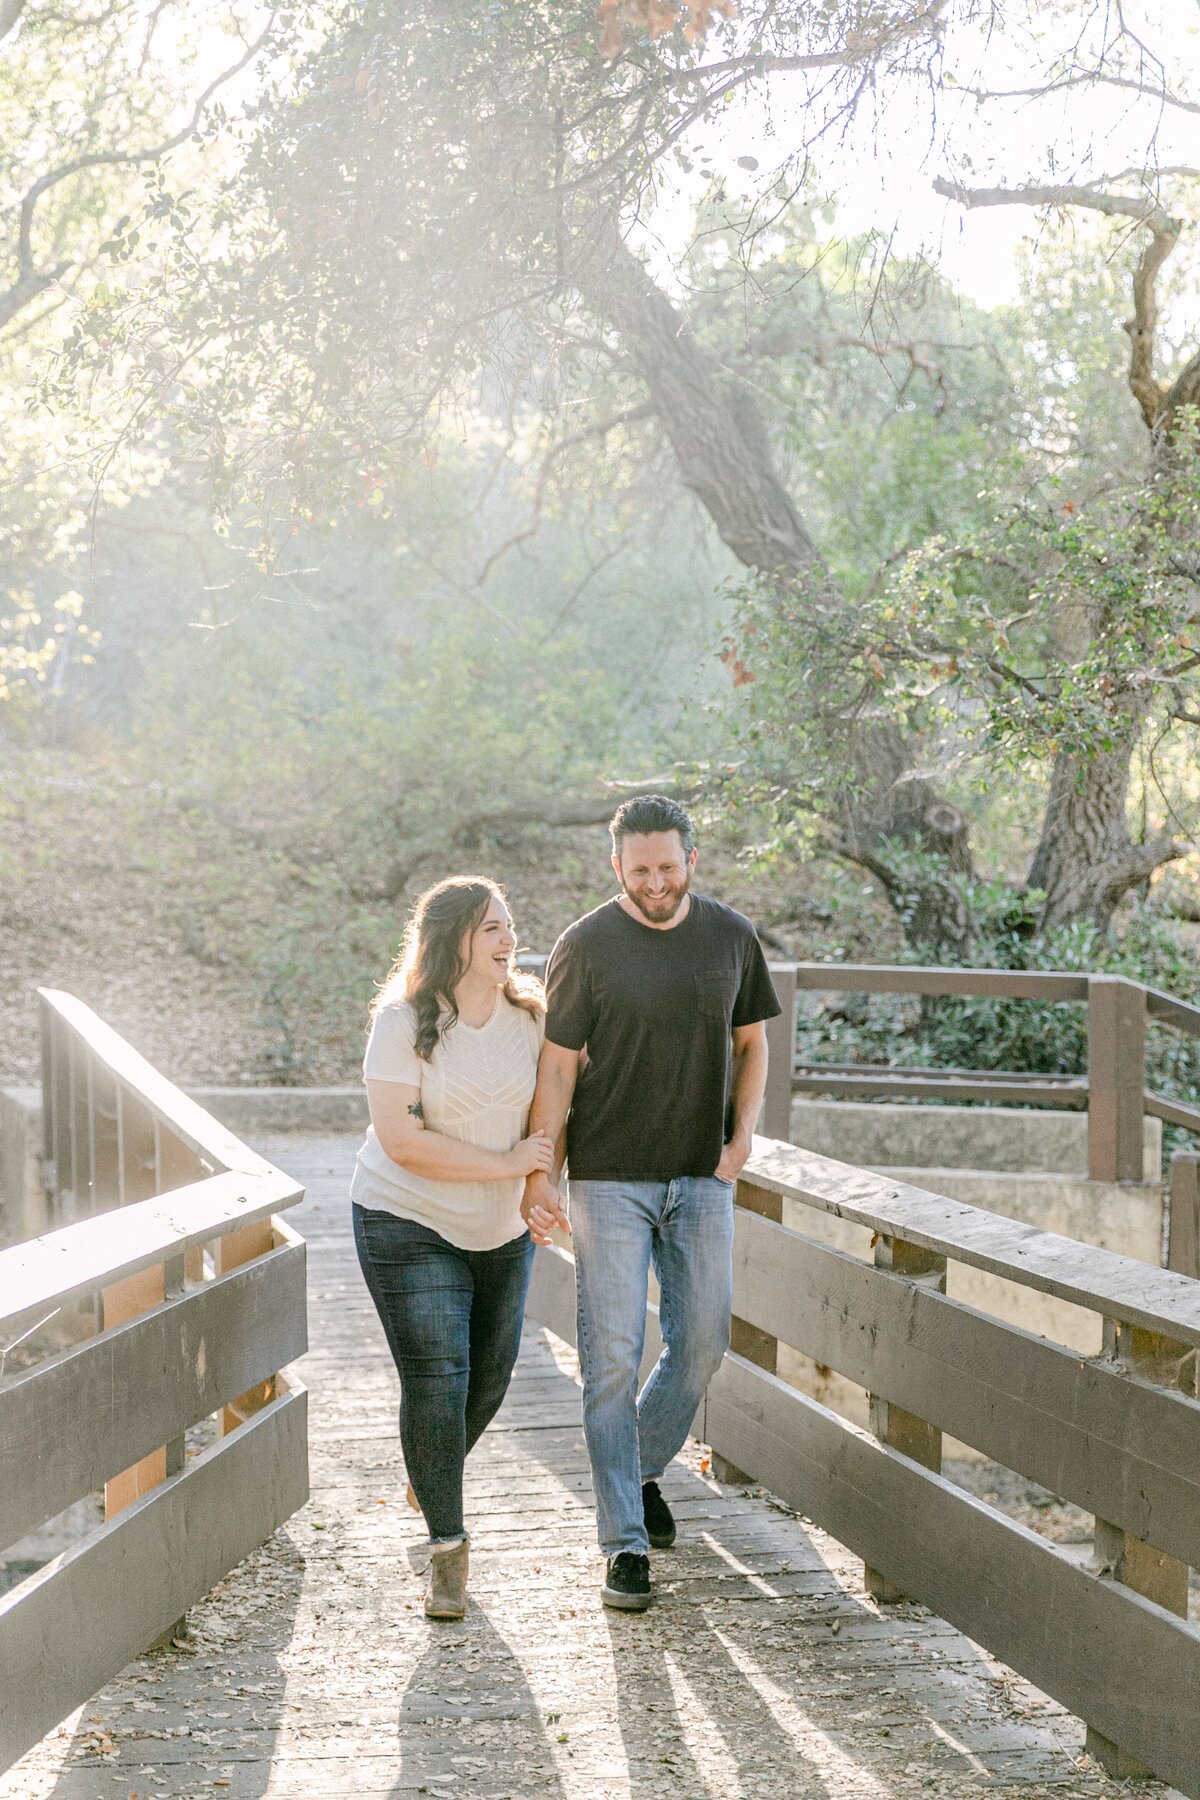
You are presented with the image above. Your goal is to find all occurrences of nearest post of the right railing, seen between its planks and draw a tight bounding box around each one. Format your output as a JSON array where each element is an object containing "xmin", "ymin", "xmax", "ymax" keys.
[{"xmin": 1087, "ymin": 1319, "xmax": 1196, "ymax": 1780}]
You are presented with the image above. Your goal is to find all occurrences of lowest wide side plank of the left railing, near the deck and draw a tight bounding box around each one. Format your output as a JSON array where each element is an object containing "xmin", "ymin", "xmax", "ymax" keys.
[{"xmin": 0, "ymin": 1388, "xmax": 308, "ymax": 1768}]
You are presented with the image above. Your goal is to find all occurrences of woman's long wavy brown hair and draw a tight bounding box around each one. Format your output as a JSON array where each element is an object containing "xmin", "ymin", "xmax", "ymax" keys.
[{"xmin": 371, "ymin": 875, "xmax": 545, "ymax": 1062}]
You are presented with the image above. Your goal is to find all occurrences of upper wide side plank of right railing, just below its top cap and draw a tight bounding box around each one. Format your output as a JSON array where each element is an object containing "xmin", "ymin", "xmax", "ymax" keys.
[{"xmin": 734, "ymin": 1211, "xmax": 1200, "ymax": 1564}]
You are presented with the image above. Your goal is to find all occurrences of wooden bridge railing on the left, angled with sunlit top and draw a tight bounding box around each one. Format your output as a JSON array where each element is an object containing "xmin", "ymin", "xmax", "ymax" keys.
[{"xmin": 0, "ymin": 990, "xmax": 308, "ymax": 1768}]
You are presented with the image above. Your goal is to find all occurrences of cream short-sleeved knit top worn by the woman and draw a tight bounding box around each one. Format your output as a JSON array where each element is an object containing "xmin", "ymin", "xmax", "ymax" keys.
[{"xmin": 351, "ymin": 994, "xmax": 545, "ymax": 1249}]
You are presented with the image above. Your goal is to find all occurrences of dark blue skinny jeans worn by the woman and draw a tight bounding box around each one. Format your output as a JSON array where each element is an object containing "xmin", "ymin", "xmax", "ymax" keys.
[{"xmin": 353, "ymin": 1206, "xmax": 533, "ymax": 1544}]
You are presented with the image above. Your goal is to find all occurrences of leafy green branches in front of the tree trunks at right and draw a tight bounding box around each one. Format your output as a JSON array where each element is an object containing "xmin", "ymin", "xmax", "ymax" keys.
[{"xmin": 725, "ymin": 421, "xmax": 1200, "ymax": 853}]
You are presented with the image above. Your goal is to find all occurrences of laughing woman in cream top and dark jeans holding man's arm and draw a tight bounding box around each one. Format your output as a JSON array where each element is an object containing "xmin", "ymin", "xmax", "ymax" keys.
[{"xmin": 351, "ymin": 877, "xmax": 554, "ymax": 1618}]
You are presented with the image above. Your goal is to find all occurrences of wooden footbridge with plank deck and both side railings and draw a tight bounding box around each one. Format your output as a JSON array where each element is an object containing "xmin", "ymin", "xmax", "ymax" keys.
[{"xmin": 0, "ymin": 995, "xmax": 1200, "ymax": 1800}]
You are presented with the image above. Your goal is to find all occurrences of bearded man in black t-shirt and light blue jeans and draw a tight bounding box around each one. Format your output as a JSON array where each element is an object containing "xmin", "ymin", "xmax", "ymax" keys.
[{"xmin": 522, "ymin": 794, "xmax": 779, "ymax": 1613}]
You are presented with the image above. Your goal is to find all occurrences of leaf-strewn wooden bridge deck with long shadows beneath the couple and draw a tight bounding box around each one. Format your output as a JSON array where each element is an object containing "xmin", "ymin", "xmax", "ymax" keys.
[{"xmin": 0, "ymin": 1138, "xmax": 1168, "ymax": 1800}]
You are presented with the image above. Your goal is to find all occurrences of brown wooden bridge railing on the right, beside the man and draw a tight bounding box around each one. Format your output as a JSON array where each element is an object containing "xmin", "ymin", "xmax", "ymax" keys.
[{"xmin": 529, "ymin": 1138, "xmax": 1200, "ymax": 1800}]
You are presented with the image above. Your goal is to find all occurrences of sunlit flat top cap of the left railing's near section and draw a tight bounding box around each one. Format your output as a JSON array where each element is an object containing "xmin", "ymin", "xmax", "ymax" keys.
[{"xmin": 0, "ymin": 1163, "xmax": 304, "ymax": 1336}]
